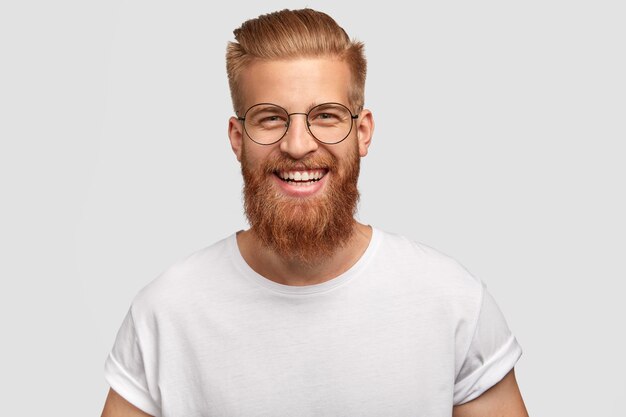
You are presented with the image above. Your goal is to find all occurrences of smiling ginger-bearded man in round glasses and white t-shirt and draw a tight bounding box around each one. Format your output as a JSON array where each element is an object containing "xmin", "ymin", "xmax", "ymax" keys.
[{"xmin": 103, "ymin": 9, "xmax": 527, "ymax": 417}]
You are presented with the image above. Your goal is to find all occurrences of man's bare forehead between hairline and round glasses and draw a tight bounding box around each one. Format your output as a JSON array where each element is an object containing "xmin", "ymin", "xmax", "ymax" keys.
[{"xmin": 239, "ymin": 58, "xmax": 351, "ymax": 111}]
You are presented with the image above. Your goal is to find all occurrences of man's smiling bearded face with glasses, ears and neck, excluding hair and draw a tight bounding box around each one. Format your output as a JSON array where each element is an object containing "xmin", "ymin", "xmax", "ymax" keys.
[{"xmin": 229, "ymin": 57, "xmax": 374, "ymax": 285}]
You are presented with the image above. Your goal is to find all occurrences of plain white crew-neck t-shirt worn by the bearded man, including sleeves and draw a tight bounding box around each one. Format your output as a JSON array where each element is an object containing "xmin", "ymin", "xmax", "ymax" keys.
[{"xmin": 105, "ymin": 229, "xmax": 521, "ymax": 417}]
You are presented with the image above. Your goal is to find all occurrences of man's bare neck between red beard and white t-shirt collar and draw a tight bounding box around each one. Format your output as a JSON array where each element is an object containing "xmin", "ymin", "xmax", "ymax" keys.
[{"xmin": 237, "ymin": 221, "xmax": 372, "ymax": 286}]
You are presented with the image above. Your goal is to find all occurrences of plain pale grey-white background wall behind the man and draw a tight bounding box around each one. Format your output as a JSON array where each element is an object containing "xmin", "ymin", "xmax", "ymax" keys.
[{"xmin": 0, "ymin": 0, "xmax": 626, "ymax": 416}]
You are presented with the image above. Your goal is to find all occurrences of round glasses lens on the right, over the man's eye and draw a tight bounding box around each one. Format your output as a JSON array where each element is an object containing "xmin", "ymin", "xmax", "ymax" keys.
[{"xmin": 308, "ymin": 103, "xmax": 352, "ymax": 143}]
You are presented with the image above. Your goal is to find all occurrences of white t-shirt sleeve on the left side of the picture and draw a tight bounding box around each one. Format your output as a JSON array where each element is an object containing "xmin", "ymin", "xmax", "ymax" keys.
[{"xmin": 104, "ymin": 308, "xmax": 161, "ymax": 417}]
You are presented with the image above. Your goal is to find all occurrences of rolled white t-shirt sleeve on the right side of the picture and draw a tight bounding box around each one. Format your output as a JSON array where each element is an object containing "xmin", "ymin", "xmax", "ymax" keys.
[{"xmin": 454, "ymin": 286, "xmax": 522, "ymax": 405}]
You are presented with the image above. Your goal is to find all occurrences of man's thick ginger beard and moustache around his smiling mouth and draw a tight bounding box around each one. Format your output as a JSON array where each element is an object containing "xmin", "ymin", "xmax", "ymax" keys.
[{"xmin": 241, "ymin": 146, "xmax": 360, "ymax": 266}]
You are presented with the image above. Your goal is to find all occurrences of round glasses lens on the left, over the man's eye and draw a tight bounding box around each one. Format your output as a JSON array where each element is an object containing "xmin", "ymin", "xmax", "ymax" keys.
[{"xmin": 244, "ymin": 104, "xmax": 289, "ymax": 145}]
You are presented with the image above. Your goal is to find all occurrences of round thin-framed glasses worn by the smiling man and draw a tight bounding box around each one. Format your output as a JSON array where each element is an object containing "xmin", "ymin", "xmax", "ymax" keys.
[{"xmin": 237, "ymin": 103, "xmax": 359, "ymax": 145}]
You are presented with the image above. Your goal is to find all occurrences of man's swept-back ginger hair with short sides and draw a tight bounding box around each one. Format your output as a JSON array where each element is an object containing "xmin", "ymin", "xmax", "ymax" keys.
[{"xmin": 226, "ymin": 9, "xmax": 367, "ymax": 113}]
